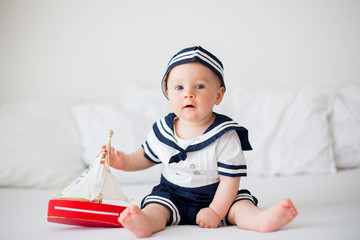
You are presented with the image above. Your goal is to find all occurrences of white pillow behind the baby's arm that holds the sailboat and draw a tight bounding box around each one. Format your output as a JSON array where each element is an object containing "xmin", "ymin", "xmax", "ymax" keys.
[{"xmin": 73, "ymin": 103, "xmax": 161, "ymax": 183}]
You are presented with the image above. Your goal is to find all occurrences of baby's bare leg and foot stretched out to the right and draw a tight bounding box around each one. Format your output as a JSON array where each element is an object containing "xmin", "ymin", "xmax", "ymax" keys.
[{"xmin": 228, "ymin": 199, "xmax": 297, "ymax": 232}]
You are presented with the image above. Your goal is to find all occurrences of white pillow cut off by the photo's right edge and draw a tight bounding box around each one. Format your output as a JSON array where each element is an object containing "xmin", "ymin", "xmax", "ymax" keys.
[{"xmin": 331, "ymin": 86, "xmax": 360, "ymax": 168}]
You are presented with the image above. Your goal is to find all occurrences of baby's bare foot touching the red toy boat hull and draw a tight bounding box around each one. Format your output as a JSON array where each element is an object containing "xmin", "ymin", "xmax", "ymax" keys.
[{"xmin": 119, "ymin": 206, "xmax": 152, "ymax": 238}]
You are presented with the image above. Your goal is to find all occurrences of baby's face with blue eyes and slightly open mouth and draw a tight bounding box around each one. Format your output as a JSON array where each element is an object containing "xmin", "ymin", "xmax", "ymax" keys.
[{"xmin": 165, "ymin": 62, "xmax": 225, "ymax": 124}]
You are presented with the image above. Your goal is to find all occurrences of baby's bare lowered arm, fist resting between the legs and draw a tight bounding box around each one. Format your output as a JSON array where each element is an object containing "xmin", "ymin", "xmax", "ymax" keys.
[{"xmin": 196, "ymin": 176, "xmax": 240, "ymax": 228}]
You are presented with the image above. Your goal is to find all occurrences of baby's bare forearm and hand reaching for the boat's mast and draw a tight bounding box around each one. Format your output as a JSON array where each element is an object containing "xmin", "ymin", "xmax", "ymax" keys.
[{"xmin": 103, "ymin": 146, "xmax": 154, "ymax": 171}]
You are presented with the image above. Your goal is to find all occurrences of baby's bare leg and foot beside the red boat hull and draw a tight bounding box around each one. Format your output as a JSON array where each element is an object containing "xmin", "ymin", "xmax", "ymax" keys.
[{"xmin": 119, "ymin": 204, "xmax": 170, "ymax": 238}]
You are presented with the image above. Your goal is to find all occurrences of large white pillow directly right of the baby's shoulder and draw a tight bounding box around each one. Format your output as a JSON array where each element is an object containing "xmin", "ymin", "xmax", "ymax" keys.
[{"xmin": 231, "ymin": 88, "xmax": 336, "ymax": 176}]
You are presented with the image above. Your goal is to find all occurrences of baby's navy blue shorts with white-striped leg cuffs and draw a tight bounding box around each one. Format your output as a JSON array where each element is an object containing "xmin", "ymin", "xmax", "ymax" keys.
[{"xmin": 141, "ymin": 176, "xmax": 258, "ymax": 225}]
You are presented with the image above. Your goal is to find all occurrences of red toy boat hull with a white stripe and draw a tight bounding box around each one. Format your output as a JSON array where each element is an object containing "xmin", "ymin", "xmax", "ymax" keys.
[{"xmin": 47, "ymin": 199, "xmax": 126, "ymax": 227}]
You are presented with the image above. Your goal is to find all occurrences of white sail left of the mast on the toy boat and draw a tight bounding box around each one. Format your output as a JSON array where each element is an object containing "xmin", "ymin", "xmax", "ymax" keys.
[{"xmin": 55, "ymin": 155, "xmax": 102, "ymax": 201}]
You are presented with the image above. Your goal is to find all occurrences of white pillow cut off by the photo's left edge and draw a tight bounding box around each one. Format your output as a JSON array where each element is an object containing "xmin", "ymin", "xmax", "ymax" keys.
[{"xmin": 0, "ymin": 102, "xmax": 85, "ymax": 188}]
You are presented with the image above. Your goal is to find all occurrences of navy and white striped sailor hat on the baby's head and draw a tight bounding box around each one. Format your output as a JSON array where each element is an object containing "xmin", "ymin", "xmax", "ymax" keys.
[{"xmin": 161, "ymin": 46, "xmax": 225, "ymax": 96}]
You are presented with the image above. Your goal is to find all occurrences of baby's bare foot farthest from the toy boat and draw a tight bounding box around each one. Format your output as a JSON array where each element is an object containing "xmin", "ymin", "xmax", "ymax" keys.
[{"xmin": 259, "ymin": 199, "xmax": 298, "ymax": 232}]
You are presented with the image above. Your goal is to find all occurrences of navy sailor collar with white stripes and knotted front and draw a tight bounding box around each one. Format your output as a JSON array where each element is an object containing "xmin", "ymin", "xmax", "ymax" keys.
[{"xmin": 153, "ymin": 112, "xmax": 252, "ymax": 163}]
